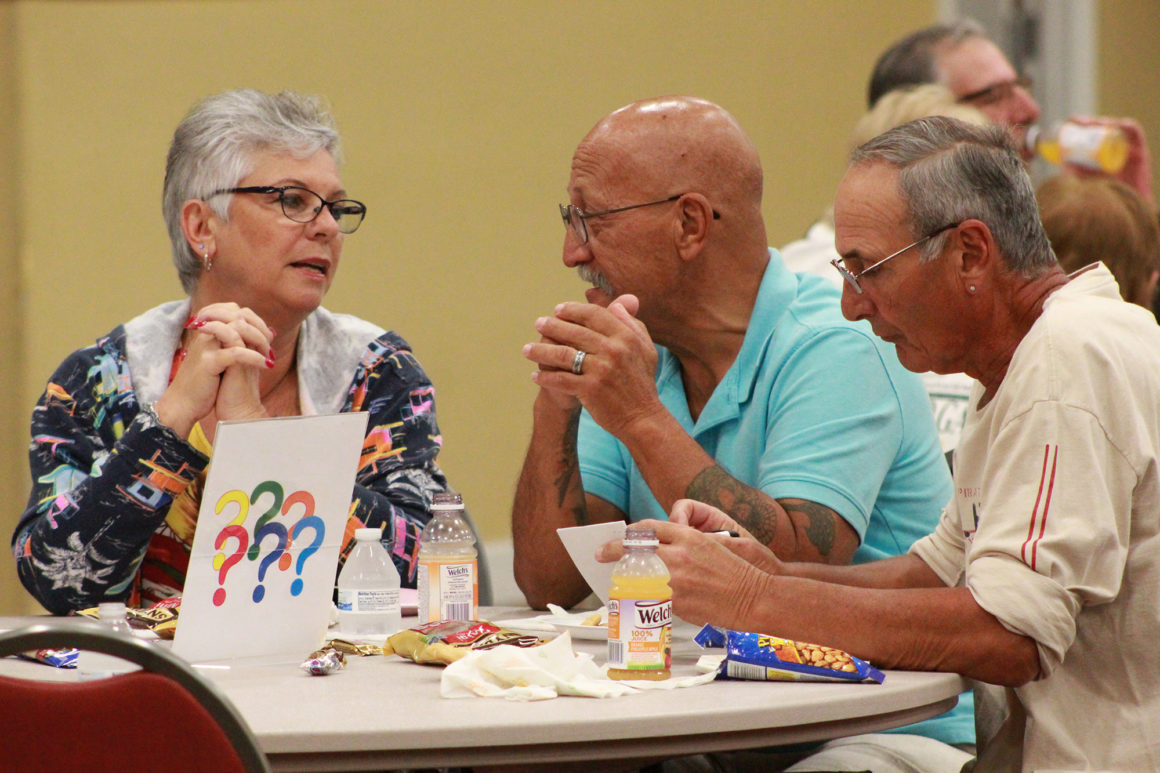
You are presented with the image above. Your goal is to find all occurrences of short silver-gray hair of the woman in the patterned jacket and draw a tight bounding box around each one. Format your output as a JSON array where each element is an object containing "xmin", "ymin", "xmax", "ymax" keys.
[{"xmin": 161, "ymin": 88, "xmax": 341, "ymax": 292}]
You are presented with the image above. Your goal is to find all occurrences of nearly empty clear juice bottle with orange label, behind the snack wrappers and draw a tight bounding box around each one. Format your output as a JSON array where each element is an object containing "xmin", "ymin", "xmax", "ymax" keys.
[{"xmin": 418, "ymin": 492, "xmax": 479, "ymax": 623}]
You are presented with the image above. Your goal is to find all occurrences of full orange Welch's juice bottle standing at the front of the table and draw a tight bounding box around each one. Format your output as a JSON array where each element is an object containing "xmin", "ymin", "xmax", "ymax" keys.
[{"xmin": 608, "ymin": 523, "xmax": 673, "ymax": 680}]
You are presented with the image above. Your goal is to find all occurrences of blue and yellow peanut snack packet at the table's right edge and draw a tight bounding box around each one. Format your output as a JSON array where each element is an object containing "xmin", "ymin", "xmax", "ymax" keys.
[{"xmin": 694, "ymin": 626, "xmax": 886, "ymax": 684}]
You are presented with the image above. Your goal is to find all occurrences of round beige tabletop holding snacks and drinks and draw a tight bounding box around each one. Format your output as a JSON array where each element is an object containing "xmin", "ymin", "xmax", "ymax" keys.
[{"xmin": 0, "ymin": 608, "xmax": 966, "ymax": 771}]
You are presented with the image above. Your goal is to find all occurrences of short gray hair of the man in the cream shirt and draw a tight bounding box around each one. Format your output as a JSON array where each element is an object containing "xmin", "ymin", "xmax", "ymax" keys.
[{"xmin": 850, "ymin": 116, "xmax": 1057, "ymax": 272}]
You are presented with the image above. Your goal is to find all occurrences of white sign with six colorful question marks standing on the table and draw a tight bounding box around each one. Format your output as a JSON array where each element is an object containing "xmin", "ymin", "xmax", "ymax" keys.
[{"xmin": 173, "ymin": 413, "xmax": 367, "ymax": 663}]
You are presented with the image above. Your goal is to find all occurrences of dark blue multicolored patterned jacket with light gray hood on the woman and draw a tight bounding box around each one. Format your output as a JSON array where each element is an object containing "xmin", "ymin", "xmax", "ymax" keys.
[{"xmin": 13, "ymin": 301, "xmax": 447, "ymax": 614}]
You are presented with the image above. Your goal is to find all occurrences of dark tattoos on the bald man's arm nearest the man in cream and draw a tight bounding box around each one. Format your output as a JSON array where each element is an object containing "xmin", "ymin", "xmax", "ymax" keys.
[{"xmin": 684, "ymin": 464, "xmax": 838, "ymax": 556}]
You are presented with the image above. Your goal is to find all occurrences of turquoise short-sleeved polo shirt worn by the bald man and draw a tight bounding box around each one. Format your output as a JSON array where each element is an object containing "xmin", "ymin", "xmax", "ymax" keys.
[{"xmin": 578, "ymin": 250, "xmax": 974, "ymax": 743}]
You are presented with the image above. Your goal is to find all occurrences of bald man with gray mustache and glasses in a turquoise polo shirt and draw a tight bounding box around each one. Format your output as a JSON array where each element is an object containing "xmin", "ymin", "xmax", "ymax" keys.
[{"xmin": 512, "ymin": 96, "xmax": 973, "ymax": 766}]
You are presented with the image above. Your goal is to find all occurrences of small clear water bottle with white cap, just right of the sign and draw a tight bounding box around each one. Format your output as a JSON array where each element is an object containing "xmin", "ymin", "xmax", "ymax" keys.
[{"xmin": 339, "ymin": 528, "xmax": 403, "ymax": 637}]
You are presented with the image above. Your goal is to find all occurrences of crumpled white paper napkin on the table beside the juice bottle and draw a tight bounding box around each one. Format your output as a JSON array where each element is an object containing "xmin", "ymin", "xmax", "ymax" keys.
[{"xmin": 440, "ymin": 633, "xmax": 717, "ymax": 701}]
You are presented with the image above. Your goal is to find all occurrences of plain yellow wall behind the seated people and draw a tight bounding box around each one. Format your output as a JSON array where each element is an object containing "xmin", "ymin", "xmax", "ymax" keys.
[{"xmin": 0, "ymin": 0, "xmax": 1160, "ymax": 614}]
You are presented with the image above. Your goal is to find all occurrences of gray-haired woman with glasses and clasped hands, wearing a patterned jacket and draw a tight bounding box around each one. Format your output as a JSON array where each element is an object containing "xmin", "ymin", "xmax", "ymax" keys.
[{"xmin": 13, "ymin": 89, "xmax": 447, "ymax": 614}]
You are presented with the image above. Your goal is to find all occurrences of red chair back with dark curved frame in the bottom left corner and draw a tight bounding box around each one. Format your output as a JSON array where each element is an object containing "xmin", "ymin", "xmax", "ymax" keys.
[{"xmin": 0, "ymin": 619, "xmax": 270, "ymax": 773}]
